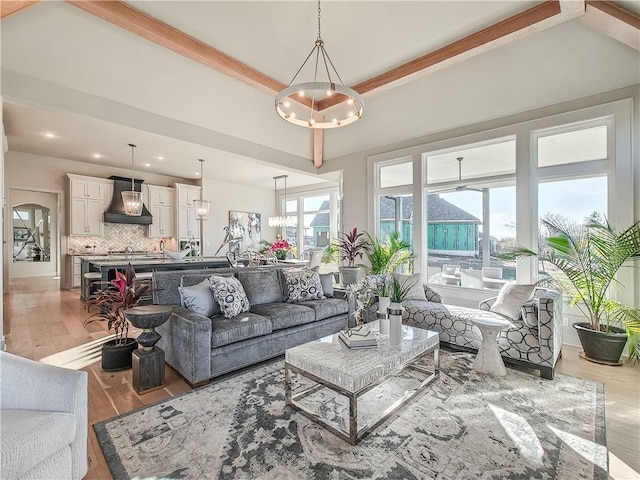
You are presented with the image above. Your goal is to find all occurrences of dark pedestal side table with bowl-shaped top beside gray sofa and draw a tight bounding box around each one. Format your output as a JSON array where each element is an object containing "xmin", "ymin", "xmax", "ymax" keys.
[{"xmin": 124, "ymin": 305, "xmax": 173, "ymax": 394}]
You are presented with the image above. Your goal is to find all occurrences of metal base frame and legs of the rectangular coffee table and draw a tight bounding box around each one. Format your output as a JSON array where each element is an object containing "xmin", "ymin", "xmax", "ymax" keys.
[{"xmin": 284, "ymin": 344, "xmax": 440, "ymax": 445}]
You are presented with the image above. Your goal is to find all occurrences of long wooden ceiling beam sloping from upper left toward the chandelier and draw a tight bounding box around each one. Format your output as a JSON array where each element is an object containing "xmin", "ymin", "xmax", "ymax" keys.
[{"xmin": 65, "ymin": 0, "xmax": 285, "ymax": 94}]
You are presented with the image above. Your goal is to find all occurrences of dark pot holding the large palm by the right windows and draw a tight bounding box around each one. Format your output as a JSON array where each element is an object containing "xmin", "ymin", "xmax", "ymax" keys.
[{"xmin": 572, "ymin": 322, "xmax": 627, "ymax": 365}]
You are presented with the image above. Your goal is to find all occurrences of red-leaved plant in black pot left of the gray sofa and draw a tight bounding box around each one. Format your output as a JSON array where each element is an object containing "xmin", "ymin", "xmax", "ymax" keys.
[{"xmin": 84, "ymin": 264, "xmax": 150, "ymax": 372}]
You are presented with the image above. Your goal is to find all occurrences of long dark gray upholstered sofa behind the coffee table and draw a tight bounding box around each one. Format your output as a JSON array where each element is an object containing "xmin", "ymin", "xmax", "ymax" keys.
[{"xmin": 153, "ymin": 266, "xmax": 349, "ymax": 384}]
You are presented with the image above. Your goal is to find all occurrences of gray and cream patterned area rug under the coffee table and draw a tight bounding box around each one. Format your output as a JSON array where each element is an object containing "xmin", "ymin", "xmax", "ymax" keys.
[{"xmin": 94, "ymin": 352, "xmax": 608, "ymax": 480}]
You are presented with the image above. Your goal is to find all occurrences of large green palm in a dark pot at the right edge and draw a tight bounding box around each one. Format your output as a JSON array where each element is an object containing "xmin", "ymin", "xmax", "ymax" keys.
[{"xmin": 508, "ymin": 214, "xmax": 640, "ymax": 365}]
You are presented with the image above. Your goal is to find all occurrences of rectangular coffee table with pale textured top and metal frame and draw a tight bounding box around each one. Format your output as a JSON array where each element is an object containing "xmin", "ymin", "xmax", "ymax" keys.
[{"xmin": 284, "ymin": 322, "xmax": 440, "ymax": 445}]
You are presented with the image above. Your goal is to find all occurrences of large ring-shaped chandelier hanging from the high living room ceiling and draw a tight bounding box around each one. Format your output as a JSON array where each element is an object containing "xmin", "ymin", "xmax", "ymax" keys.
[{"xmin": 276, "ymin": 0, "xmax": 364, "ymax": 129}]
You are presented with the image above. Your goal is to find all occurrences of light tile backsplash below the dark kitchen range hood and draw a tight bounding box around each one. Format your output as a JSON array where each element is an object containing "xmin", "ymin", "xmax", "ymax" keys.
[{"xmin": 68, "ymin": 223, "xmax": 174, "ymax": 254}]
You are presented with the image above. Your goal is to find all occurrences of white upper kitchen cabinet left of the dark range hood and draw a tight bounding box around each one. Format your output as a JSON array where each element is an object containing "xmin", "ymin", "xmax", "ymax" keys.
[{"xmin": 67, "ymin": 174, "xmax": 113, "ymax": 236}]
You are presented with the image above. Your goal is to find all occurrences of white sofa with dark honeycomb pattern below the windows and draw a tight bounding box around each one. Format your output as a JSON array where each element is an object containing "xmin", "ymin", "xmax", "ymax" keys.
[{"xmin": 362, "ymin": 276, "xmax": 562, "ymax": 379}]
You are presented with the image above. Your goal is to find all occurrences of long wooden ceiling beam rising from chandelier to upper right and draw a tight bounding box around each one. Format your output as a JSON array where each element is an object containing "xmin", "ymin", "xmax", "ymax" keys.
[{"xmin": 318, "ymin": 1, "xmax": 566, "ymax": 110}]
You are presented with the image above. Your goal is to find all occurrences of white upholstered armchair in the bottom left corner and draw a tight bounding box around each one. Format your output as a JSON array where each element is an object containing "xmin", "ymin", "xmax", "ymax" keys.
[{"xmin": 0, "ymin": 352, "xmax": 88, "ymax": 480}]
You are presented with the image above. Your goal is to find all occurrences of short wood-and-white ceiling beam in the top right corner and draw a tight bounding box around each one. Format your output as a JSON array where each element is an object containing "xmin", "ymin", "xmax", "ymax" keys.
[{"xmin": 582, "ymin": 0, "xmax": 640, "ymax": 50}]
